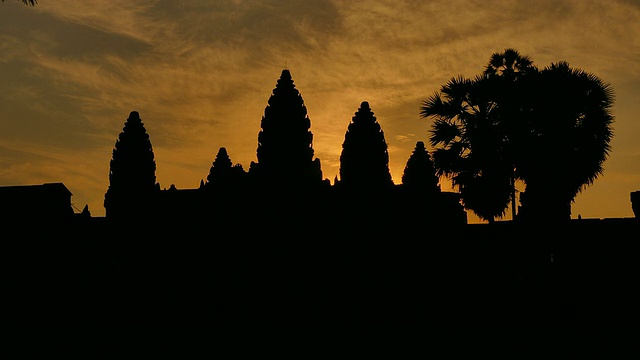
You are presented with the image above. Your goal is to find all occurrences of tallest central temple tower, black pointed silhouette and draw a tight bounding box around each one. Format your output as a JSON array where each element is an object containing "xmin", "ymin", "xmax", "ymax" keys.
[{"xmin": 249, "ymin": 69, "xmax": 322, "ymax": 186}]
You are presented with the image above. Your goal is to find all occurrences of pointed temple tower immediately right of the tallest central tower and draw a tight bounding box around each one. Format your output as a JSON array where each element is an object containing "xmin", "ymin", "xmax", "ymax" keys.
[{"xmin": 340, "ymin": 101, "xmax": 393, "ymax": 190}]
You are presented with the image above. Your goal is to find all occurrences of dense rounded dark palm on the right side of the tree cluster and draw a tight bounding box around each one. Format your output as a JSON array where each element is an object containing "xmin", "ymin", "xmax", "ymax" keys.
[{"xmin": 517, "ymin": 62, "xmax": 614, "ymax": 220}]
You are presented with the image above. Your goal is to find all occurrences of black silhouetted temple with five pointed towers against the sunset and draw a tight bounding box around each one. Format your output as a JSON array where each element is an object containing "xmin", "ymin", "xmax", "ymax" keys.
[{"xmin": 104, "ymin": 69, "xmax": 467, "ymax": 226}]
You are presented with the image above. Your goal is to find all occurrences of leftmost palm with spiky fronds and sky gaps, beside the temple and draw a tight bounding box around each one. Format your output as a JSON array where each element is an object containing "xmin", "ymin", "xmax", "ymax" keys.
[{"xmin": 420, "ymin": 74, "xmax": 513, "ymax": 222}]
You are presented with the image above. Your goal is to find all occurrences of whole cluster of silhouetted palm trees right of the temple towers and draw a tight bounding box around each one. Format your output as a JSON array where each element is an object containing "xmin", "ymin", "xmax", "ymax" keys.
[{"xmin": 421, "ymin": 49, "xmax": 613, "ymax": 222}]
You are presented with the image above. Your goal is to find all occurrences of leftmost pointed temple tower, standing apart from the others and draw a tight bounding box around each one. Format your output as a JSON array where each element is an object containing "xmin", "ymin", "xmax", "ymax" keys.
[{"xmin": 104, "ymin": 111, "xmax": 159, "ymax": 217}]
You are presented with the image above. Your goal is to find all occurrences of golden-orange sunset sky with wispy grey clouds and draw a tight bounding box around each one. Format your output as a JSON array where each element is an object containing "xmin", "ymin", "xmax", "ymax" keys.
[{"xmin": 0, "ymin": 0, "xmax": 640, "ymax": 223}]
